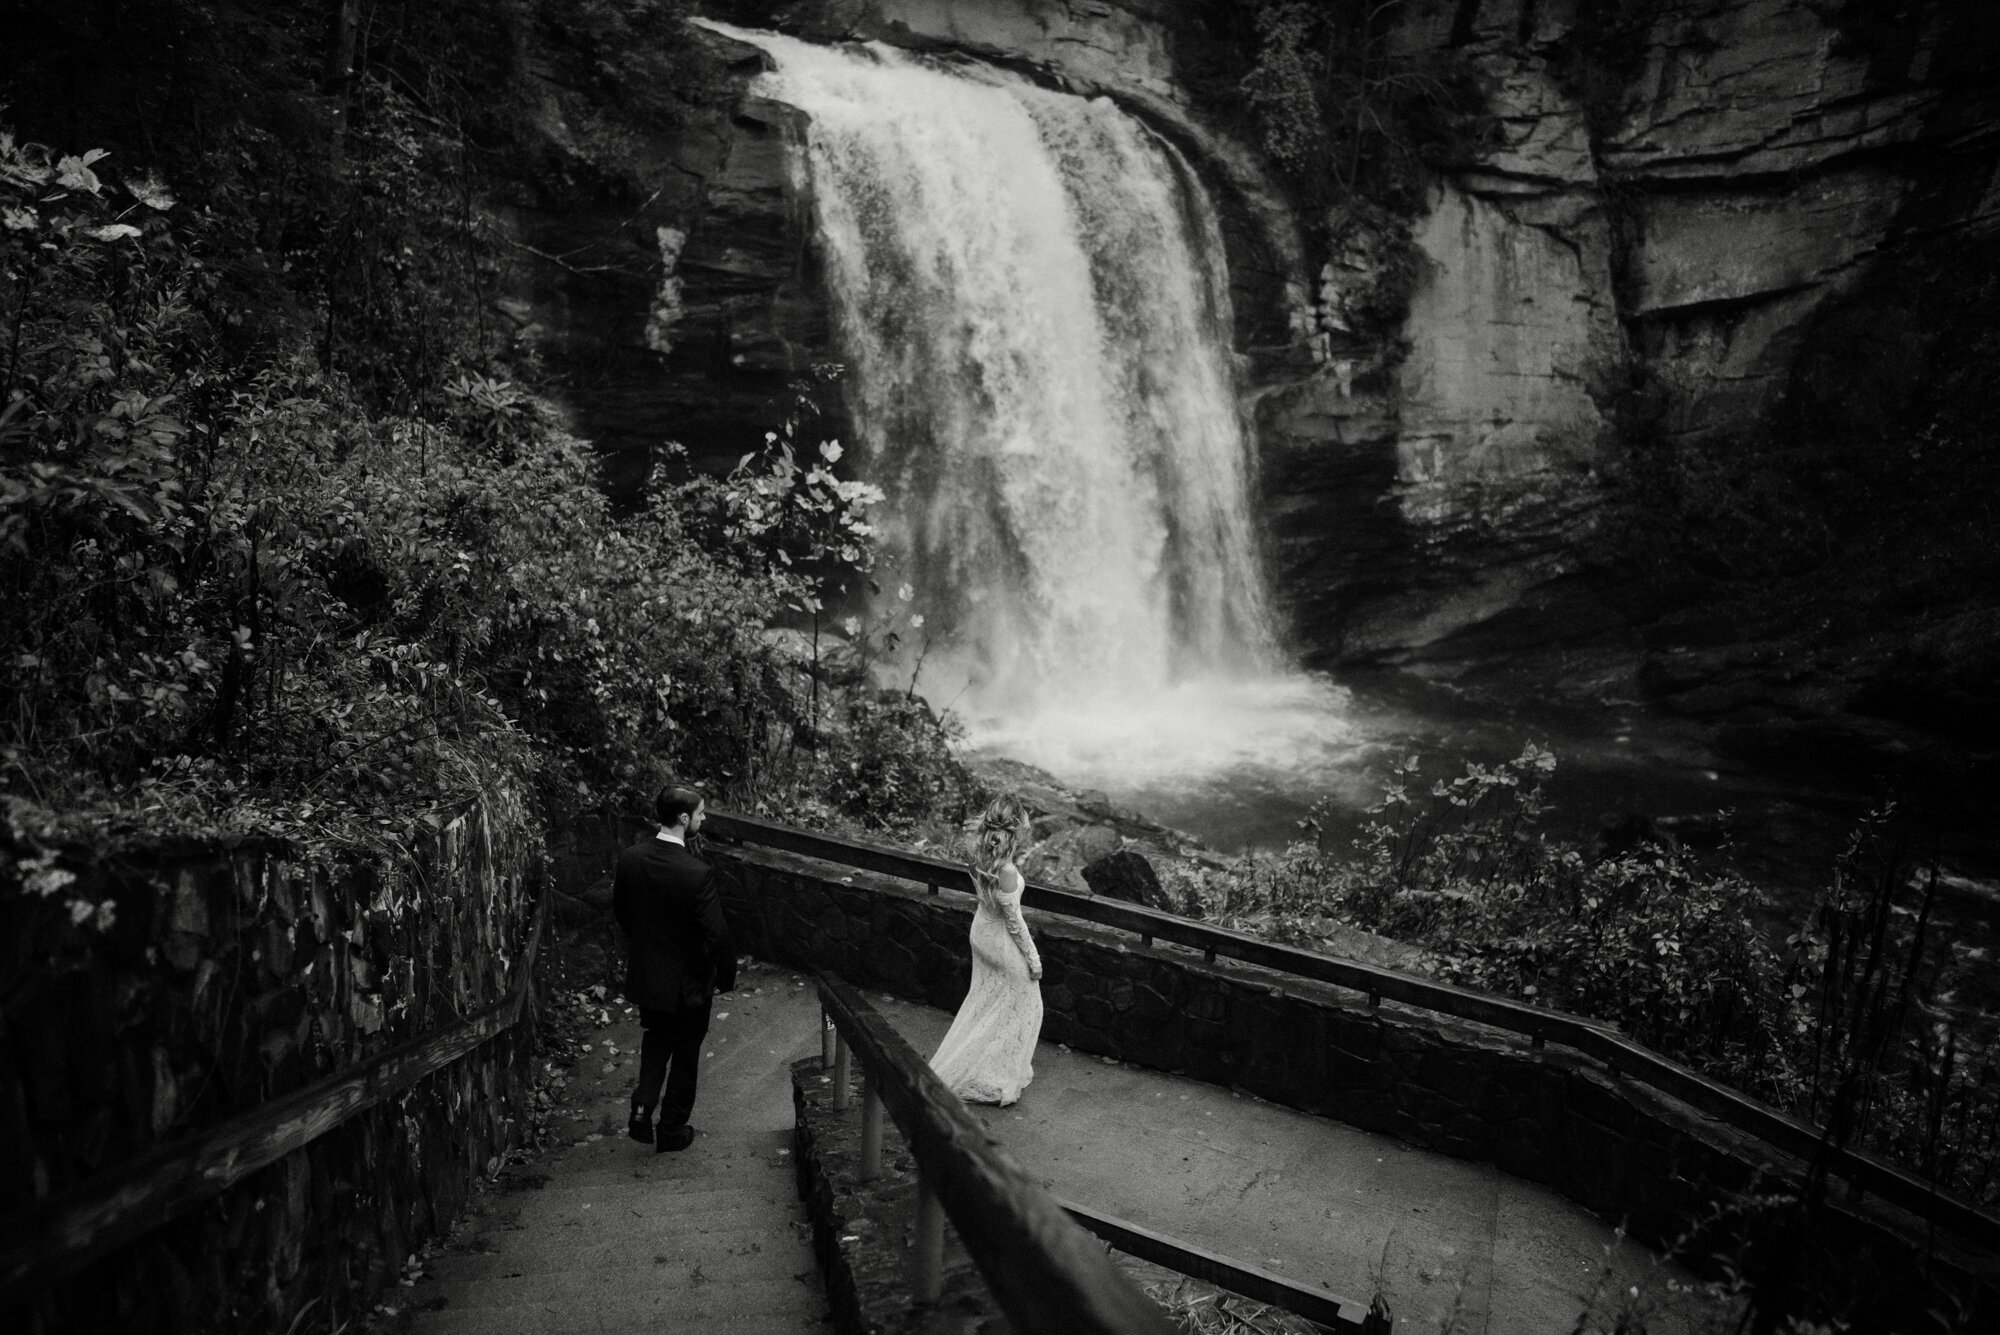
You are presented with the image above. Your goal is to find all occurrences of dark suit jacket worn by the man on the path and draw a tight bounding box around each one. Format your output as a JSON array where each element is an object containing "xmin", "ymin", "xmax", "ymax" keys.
[{"xmin": 612, "ymin": 837, "xmax": 736, "ymax": 1011}]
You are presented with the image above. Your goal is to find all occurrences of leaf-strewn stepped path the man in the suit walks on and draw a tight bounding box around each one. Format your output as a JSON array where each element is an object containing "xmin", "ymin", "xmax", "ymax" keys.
[{"xmin": 410, "ymin": 963, "xmax": 832, "ymax": 1335}]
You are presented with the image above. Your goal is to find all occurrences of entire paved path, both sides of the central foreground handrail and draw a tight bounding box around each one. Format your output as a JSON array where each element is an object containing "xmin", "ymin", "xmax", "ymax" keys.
[{"xmin": 412, "ymin": 965, "xmax": 1698, "ymax": 1335}]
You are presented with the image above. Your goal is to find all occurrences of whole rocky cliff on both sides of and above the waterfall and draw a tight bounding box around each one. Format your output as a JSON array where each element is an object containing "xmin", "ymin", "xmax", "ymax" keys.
[{"xmin": 492, "ymin": 0, "xmax": 2000, "ymax": 671}]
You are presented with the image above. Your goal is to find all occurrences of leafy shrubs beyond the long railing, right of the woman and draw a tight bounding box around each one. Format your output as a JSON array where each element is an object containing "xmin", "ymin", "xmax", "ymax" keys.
[{"xmin": 1188, "ymin": 745, "xmax": 2000, "ymax": 1201}]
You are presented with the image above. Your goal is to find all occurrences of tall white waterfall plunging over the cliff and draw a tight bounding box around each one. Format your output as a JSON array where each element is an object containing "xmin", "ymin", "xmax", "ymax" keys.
[{"xmin": 714, "ymin": 24, "xmax": 1344, "ymax": 803}]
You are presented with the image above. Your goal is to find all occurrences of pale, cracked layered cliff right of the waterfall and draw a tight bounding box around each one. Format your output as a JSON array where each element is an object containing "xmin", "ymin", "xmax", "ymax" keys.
[{"xmin": 1260, "ymin": 0, "xmax": 2000, "ymax": 664}]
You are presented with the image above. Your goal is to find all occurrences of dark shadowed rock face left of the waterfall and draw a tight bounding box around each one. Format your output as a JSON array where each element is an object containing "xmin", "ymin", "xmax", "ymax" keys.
[{"xmin": 484, "ymin": 38, "xmax": 830, "ymax": 496}]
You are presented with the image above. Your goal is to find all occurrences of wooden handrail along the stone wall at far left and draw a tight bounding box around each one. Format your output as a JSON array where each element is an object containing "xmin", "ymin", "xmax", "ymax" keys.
[{"xmin": 0, "ymin": 895, "xmax": 548, "ymax": 1311}]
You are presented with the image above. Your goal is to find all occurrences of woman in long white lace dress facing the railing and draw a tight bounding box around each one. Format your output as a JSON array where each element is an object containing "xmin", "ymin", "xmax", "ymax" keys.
[{"xmin": 930, "ymin": 797, "xmax": 1042, "ymax": 1107}]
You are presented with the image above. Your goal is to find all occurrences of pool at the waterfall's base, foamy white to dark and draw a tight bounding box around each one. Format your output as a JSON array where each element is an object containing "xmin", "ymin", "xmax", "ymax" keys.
[{"xmin": 970, "ymin": 673, "xmax": 1868, "ymax": 885}]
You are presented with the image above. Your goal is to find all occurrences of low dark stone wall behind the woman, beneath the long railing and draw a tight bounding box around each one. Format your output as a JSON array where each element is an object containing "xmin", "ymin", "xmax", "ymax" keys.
[{"xmin": 718, "ymin": 849, "xmax": 2000, "ymax": 1331}]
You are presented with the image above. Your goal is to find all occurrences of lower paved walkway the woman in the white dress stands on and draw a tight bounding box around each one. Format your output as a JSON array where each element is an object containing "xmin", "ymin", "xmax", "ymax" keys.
[{"xmin": 870, "ymin": 995, "xmax": 1700, "ymax": 1335}]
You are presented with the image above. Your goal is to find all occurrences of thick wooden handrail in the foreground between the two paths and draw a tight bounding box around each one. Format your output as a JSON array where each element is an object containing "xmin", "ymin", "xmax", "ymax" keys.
[{"xmin": 818, "ymin": 973, "xmax": 1174, "ymax": 1335}]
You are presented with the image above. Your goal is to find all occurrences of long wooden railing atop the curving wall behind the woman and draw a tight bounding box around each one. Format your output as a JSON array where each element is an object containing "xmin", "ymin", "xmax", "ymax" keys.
[{"xmin": 706, "ymin": 809, "xmax": 2000, "ymax": 1251}]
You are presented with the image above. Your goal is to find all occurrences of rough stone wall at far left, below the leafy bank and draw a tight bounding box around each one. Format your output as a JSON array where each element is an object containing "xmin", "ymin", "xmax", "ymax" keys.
[{"xmin": 0, "ymin": 805, "xmax": 540, "ymax": 1335}]
